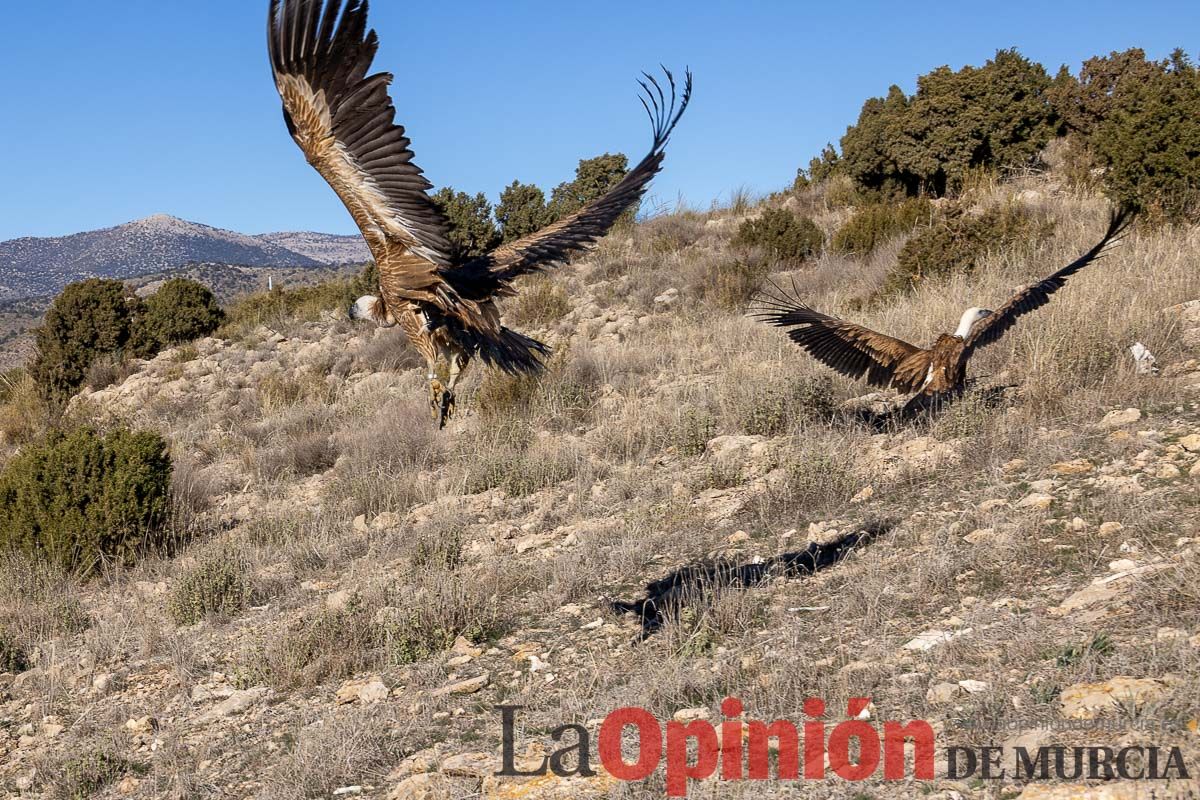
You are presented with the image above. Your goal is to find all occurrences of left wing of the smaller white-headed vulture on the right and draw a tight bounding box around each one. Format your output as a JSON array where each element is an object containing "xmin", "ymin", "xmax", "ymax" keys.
[{"xmin": 751, "ymin": 281, "xmax": 929, "ymax": 392}]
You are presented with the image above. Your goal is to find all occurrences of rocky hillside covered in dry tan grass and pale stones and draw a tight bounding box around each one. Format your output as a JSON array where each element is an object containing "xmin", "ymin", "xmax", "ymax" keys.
[{"xmin": 0, "ymin": 181, "xmax": 1200, "ymax": 800}]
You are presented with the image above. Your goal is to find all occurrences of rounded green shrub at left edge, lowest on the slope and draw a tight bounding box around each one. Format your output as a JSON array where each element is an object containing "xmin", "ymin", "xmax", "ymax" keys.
[{"xmin": 0, "ymin": 427, "xmax": 172, "ymax": 573}]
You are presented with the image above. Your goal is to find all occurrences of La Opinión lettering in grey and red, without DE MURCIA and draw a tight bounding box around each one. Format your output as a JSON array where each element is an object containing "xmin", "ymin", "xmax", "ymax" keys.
[{"xmin": 497, "ymin": 697, "xmax": 936, "ymax": 798}]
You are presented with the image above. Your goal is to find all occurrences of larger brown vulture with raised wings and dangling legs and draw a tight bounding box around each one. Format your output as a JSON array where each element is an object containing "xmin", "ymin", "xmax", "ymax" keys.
[{"xmin": 268, "ymin": 0, "xmax": 691, "ymax": 427}]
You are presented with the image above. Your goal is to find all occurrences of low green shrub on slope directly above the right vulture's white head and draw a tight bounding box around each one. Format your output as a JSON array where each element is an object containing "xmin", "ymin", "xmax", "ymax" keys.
[{"xmin": 882, "ymin": 204, "xmax": 1054, "ymax": 295}]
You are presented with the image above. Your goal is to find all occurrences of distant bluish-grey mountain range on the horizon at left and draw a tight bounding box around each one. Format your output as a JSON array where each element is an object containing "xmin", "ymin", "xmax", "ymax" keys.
[{"xmin": 0, "ymin": 215, "xmax": 370, "ymax": 301}]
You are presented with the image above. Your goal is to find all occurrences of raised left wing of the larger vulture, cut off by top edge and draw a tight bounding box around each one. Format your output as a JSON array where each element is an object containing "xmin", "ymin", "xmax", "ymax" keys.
[{"xmin": 268, "ymin": 0, "xmax": 451, "ymax": 299}]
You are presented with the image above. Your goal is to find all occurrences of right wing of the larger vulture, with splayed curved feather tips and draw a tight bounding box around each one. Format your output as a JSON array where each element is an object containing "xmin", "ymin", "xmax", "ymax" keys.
[{"xmin": 452, "ymin": 68, "xmax": 691, "ymax": 296}]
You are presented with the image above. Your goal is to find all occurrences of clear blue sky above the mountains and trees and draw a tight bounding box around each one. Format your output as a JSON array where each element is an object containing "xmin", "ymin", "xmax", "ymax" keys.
[{"xmin": 0, "ymin": 0, "xmax": 1200, "ymax": 240}]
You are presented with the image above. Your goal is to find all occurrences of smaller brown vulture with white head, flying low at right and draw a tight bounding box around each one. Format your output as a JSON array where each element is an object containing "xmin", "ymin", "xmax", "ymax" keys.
[{"xmin": 752, "ymin": 203, "xmax": 1133, "ymax": 417}]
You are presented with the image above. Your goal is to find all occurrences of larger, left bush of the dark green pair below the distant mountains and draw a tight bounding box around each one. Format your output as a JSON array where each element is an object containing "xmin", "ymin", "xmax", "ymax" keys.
[{"xmin": 29, "ymin": 278, "xmax": 138, "ymax": 405}]
